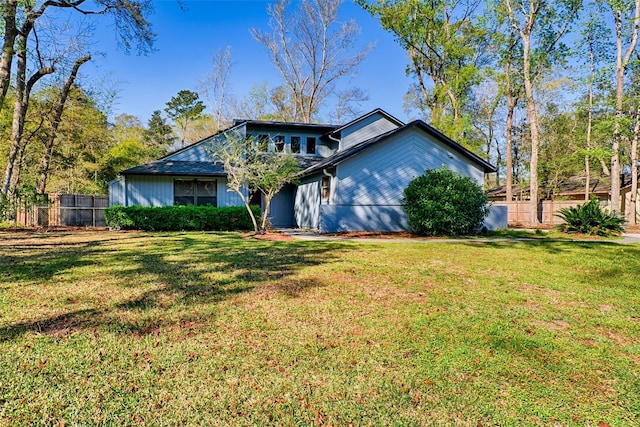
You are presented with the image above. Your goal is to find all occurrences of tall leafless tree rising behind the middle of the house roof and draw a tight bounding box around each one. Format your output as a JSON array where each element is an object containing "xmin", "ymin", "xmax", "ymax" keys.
[{"xmin": 252, "ymin": 0, "xmax": 370, "ymax": 123}]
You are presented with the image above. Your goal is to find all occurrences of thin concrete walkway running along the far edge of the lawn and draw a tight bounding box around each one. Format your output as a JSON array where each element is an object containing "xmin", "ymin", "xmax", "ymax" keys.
[{"xmin": 279, "ymin": 228, "xmax": 640, "ymax": 243}]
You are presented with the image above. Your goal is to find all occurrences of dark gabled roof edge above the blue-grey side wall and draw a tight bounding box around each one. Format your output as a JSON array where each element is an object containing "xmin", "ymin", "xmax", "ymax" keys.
[{"xmin": 303, "ymin": 120, "xmax": 496, "ymax": 175}]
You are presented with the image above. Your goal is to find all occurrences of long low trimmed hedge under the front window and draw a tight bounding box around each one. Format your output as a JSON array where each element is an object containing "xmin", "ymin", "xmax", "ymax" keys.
[{"xmin": 104, "ymin": 206, "xmax": 260, "ymax": 231}]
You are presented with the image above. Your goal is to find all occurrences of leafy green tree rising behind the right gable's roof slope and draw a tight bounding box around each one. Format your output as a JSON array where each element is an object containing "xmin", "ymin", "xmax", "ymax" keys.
[{"xmin": 358, "ymin": 0, "xmax": 488, "ymax": 151}]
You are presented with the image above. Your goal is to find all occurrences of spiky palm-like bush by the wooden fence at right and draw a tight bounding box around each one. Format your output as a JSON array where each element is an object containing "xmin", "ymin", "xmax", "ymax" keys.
[{"xmin": 556, "ymin": 199, "xmax": 624, "ymax": 237}]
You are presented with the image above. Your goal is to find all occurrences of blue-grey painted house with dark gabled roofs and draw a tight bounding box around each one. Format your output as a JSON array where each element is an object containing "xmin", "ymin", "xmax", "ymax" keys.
[{"xmin": 109, "ymin": 109, "xmax": 506, "ymax": 232}]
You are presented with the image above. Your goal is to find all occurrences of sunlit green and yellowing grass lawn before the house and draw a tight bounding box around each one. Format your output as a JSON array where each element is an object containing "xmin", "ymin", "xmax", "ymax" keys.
[{"xmin": 0, "ymin": 232, "xmax": 640, "ymax": 427}]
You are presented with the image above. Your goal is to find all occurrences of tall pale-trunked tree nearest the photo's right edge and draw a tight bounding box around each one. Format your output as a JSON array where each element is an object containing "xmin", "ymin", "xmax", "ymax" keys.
[{"xmin": 605, "ymin": 0, "xmax": 640, "ymax": 211}]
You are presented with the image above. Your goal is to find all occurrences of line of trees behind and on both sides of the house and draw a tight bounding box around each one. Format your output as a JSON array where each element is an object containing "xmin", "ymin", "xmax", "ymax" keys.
[{"xmin": 0, "ymin": 0, "xmax": 640, "ymax": 223}]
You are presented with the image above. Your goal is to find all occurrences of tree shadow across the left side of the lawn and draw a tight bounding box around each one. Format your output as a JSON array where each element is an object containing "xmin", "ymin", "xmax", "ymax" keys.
[{"xmin": 0, "ymin": 233, "xmax": 343, "ymax": 342}]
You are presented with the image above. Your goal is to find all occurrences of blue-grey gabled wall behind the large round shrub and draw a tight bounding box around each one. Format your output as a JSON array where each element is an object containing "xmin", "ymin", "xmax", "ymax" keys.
[{"xmin": 319, "ymin": 129, "xmax": 484, "ymax": 232}]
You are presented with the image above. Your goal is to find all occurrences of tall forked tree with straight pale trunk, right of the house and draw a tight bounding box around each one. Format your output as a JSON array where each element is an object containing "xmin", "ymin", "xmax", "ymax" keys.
[{"xmin": 504, "ymin": 0, "xmax": 582, "ymax": 225}]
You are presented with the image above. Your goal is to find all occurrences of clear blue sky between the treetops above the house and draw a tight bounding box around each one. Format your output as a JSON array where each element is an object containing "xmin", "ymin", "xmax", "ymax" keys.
[{"xmin": 84, "ymin": 0, "xmax": 410, "ymax": 123}]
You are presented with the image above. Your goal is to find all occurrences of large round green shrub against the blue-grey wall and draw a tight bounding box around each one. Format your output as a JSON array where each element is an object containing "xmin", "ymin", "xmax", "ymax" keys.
[{"xmin": 402, "ymin": 167, "xmax": 488, "ymax": 236}]
